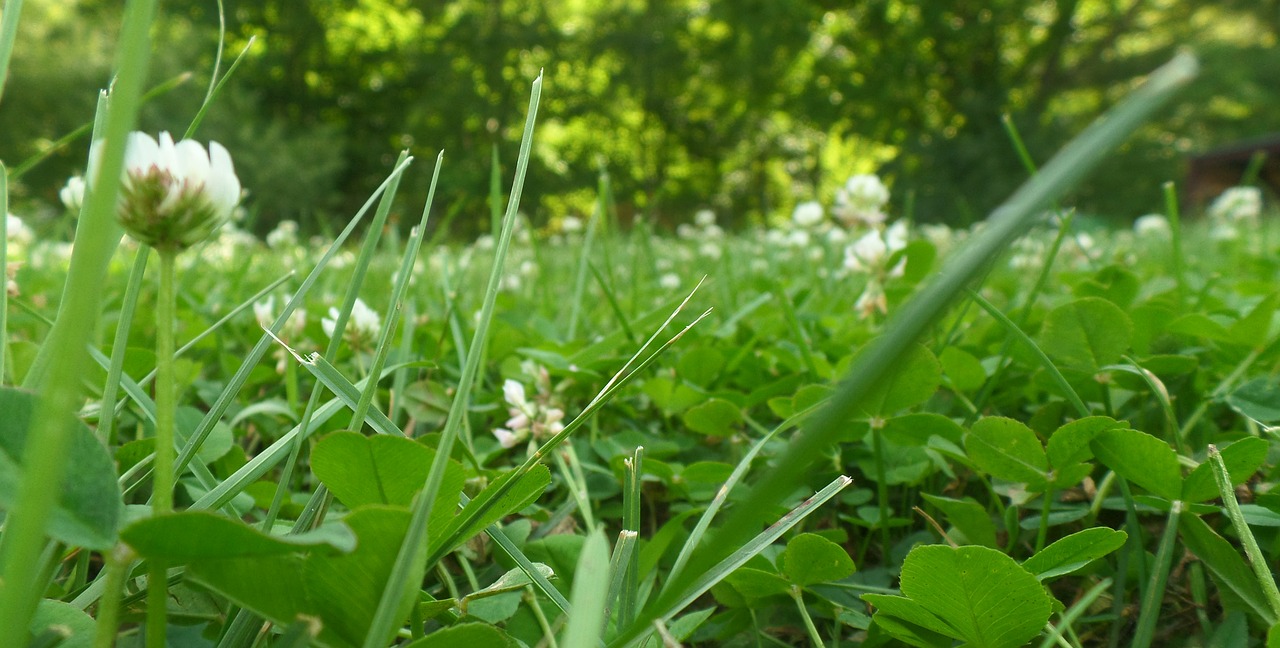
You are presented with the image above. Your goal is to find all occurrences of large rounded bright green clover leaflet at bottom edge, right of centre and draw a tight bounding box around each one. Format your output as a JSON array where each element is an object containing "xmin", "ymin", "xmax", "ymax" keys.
[{"xmin": 901, "ymin": 544, "xmax": 1052, "ymax": 648}]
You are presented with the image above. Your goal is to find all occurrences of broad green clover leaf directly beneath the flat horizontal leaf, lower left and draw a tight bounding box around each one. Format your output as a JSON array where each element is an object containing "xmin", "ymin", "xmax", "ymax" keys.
[{"xmin": 187, "ymin": 505, "xmax": 415, "ymax": 648}]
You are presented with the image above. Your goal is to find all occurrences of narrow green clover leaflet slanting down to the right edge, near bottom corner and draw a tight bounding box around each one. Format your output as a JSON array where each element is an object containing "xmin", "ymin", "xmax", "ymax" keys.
[{"xmin": 1178, "ymin": 515, "xmax": 1276, "ymax": 625}]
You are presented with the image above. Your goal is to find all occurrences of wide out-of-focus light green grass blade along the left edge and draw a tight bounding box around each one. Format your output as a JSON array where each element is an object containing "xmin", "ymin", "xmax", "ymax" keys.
[{"xmin": 0, "ymin": 0, "xmax": 156, "ymax": 635}]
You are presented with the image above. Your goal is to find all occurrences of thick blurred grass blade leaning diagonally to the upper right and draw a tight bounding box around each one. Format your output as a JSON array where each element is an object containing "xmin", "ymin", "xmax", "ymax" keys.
[{"xmin": 621, "ymin": 54, "xmax": 1197, "ymax": 648}]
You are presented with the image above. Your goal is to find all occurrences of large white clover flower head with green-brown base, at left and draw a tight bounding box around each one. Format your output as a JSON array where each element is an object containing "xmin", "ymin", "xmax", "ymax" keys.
[{"xmin": 109, "ymin": 131, "xmax": 241, "ymax": 250}]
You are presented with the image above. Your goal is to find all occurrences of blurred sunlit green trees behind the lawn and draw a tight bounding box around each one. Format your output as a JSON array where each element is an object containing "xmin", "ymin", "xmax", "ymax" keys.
[{"xmin": 0, "ymin": 0, "xmax": 1280, "ymax": 236}]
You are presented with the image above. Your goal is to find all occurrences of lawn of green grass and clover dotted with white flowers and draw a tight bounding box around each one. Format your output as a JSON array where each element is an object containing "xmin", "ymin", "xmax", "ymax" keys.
[{"xmin": 0, "ymin": 1, "xmax": 1280, "ymax": 647}]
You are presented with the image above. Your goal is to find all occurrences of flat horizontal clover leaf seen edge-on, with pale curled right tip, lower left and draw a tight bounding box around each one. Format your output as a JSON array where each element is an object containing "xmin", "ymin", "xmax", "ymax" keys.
[{"xmin": 120, "ymin": 511, "xmax": 356, "ymax": 563}]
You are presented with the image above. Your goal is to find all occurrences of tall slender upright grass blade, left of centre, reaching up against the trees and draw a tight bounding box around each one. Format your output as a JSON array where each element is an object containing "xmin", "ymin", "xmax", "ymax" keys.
[{"xmin": 364, "ymin": 74, "xmax": 543, "ymax": 648}]
